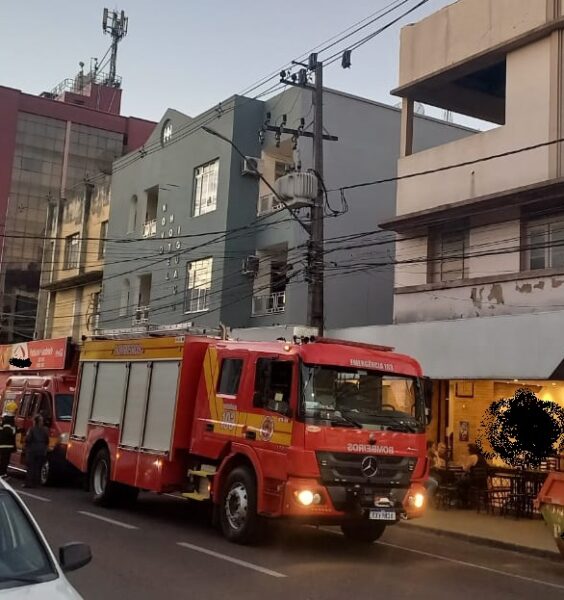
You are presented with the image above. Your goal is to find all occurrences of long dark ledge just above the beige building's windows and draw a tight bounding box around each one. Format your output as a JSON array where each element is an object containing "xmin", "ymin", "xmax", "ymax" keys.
[{"xmin": 378, "ymin": 177, "xmax": 564, "ymax": 233}]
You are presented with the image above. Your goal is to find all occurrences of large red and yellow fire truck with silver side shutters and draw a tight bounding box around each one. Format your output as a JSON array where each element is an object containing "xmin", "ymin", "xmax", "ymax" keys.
[{"xmin": 67, "ymin": 335, "xmax": 429, "ymax": 543}]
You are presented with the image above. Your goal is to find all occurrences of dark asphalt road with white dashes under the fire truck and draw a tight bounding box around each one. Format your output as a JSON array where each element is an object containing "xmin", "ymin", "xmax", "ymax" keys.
[{"xmin": 8, "ymin": 480, "xmax": 564, "ymax": 600}]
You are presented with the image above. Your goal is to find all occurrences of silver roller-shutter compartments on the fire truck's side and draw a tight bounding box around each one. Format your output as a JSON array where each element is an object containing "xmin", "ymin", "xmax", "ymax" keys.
[{"xmin": 74, "ymin": 360, "xmax": 180, "ymax": 452}]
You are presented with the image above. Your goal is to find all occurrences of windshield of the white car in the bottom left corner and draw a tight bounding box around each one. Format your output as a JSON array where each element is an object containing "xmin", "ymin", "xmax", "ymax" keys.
[{"xmin": 0, "ymin": 490, "xmax": 58, "ymax": 589}]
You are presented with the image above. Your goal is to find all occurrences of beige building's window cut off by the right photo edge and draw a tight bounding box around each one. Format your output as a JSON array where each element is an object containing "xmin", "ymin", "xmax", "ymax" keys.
[{"xmin": 525, "ymin": 213, "xmax": 564, "ymax": 270}]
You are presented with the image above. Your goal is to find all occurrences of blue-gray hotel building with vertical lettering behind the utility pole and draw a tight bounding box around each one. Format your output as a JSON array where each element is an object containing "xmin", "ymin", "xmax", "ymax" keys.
[{"xmin": 99, "ymin": 88, "xmax": 470, "ymax": 329}]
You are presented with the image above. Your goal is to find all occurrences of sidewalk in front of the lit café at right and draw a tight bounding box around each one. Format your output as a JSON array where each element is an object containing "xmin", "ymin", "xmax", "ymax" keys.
[{"xmin": 402, "ymin": 508, "xmax": 562, "ymax": 560}]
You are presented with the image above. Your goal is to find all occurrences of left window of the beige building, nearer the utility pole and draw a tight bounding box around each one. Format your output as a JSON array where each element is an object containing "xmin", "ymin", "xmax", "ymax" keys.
[{"xmin": 428, "ymin": 229, "xmax": 468, "ymax": 283}]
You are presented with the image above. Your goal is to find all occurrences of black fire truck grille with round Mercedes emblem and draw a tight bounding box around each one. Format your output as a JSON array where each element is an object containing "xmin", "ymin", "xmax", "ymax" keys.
[{"xmin": 317, "ymin": 452, "xmax": 416, "ymax": 488}]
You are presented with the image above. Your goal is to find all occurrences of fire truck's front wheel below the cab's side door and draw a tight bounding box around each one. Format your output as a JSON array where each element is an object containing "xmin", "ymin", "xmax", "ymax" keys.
[{"xmin": 219, "ymin": 467, "xmax": 262, "ymax": 544}]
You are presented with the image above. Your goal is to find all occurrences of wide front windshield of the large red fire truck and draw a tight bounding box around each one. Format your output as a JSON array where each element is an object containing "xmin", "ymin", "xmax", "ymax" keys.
[{"xmin": 302, "ymin": 365, "xmax": 423, "ymax": 432}]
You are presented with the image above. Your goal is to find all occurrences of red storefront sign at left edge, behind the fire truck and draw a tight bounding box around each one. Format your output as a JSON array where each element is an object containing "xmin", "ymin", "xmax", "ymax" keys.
[{"xmin": 0, "ymin": 338, "xmax": 68, "ymax": 371}]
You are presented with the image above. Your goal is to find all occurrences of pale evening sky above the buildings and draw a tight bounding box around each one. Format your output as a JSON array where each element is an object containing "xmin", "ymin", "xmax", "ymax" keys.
[{"xmin": 0, "ymin": 0, "xmax": 462, "ymax": 124}]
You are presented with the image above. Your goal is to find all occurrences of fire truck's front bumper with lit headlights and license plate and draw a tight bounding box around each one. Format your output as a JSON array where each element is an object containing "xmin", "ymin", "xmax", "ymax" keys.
[{"xmin": 282, "ymin": 478, "xmax": 427, "ymax": 524}]
